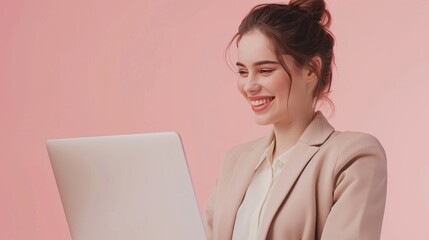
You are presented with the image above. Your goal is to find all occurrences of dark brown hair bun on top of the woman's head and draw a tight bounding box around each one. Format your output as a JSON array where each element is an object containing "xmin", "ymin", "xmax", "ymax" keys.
[{"xmin": 289, "ymin": 0, "xmax": 331, "ymax": 27}]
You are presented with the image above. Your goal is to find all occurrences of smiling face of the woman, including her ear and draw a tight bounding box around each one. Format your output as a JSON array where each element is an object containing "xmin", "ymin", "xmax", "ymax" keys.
[{"xmin": 237, "ymin": 30, "xmax": 314, "ymax": 125}]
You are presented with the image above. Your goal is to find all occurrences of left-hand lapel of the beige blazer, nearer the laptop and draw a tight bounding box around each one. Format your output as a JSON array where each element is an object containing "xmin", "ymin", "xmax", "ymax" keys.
[{"xmin": 218, "ymin": 138, "xmax": 271, "ymax": 239}]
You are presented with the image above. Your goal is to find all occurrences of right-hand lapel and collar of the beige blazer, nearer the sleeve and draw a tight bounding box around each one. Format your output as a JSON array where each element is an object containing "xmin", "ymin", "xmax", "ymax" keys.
[{"xmin": 259, "ymin": 112, "xmax": 334, "ymax": 239}]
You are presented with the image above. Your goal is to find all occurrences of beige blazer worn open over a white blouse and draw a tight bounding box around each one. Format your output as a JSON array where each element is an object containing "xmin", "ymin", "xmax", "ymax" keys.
[{"xmin": 205, "ymin": 112, "xmax": 387, "ymax": 240}]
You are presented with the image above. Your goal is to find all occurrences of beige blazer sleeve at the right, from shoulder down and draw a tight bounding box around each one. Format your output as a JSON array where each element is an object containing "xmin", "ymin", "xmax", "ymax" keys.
[{"xmin": 321, "ymin": 133, "xmax": 387, "ymax": 240}]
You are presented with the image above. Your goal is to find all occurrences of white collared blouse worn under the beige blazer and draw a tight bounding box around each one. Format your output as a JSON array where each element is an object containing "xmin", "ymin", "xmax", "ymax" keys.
[{"xmin": 232, "ymin": 140, "xmax": 293, "ymax": 240}]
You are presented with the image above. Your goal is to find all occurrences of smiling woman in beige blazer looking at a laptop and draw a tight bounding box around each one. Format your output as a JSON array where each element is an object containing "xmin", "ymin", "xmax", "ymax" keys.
[{"xmin": 205, "ymin": 0, "xmax": 387, "ymax": 240}]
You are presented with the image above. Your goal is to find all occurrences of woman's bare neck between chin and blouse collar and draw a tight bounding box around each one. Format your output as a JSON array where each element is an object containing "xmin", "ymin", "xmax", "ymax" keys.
[{"xmin": 273, "ymin": 112, "xmax": 315, "ymax": 159}]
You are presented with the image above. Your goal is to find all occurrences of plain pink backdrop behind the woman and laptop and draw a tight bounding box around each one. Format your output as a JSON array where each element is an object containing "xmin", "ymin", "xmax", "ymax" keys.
[{"xmin": 0, "ymin": 0, "xmax": 429, "ymax": 240}]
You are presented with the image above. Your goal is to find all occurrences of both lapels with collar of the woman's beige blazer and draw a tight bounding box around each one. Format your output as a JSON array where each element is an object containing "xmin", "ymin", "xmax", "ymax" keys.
[{"xmin": 218, "ymin": 111, "xmax": 334, "ymax": 239}]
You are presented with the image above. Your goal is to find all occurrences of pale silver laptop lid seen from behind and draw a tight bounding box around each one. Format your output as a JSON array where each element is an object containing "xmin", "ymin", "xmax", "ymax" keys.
[{"xmin": 47, "ymin": 132, "xmax": 206, "ymax": 240}]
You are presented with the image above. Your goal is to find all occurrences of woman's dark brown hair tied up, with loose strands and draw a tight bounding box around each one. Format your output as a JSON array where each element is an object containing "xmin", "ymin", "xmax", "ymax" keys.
[{"xmin": 228, "ymin": 0, "xmax": 335, "ymax": 105}]
